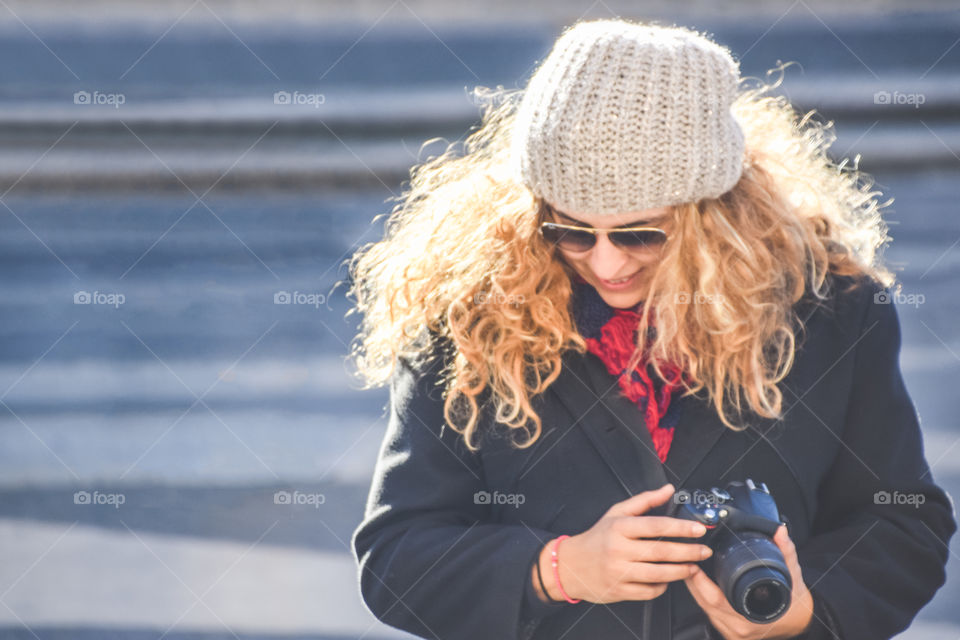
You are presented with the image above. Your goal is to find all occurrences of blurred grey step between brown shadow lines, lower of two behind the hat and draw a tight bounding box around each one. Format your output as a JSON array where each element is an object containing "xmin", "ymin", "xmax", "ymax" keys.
[{"xmin": 0, "ymin": 108, "xmax": 960, "ymax": 191}]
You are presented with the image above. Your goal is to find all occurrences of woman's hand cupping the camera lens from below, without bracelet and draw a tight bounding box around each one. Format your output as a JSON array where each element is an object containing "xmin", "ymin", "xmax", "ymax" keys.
[{"xmin": 685, "ymin": 525, "xmax": 813, "ymax": 640}]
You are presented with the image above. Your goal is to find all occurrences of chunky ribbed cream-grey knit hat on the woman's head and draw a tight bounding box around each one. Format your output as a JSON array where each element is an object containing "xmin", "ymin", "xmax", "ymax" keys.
[{"xmin": 511, "ymin": 20, "xmax": 744, "ymax": 214}]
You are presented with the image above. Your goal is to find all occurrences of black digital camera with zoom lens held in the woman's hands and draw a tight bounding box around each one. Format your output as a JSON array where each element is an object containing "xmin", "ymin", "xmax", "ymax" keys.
[{"xmin": 666, "ymin": 478, "xmax": 792, "ymax": 623}]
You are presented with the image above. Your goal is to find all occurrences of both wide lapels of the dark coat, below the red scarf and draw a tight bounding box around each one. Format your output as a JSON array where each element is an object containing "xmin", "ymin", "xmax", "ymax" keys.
[{"xmin": 550, "ymin": 350, "xmax": 727, "ymax": 497}]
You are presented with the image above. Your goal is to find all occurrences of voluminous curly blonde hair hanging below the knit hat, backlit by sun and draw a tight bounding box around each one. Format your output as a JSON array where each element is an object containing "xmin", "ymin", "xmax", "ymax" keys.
[{"xmin": 348, "ymin": 65, "xmax": 894, "ymax": 450}]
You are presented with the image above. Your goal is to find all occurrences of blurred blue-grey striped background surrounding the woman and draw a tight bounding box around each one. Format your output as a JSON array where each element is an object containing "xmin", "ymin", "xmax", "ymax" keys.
[{"xmin": 0, "ymin": 0, "xmax": 960, "ymax": 640}]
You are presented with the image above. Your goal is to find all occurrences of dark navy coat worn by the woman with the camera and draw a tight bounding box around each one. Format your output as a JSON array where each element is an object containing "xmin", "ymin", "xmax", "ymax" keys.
[{"xmin": 352, "ymin": 278, "xmax": 956, "ymax": 640}]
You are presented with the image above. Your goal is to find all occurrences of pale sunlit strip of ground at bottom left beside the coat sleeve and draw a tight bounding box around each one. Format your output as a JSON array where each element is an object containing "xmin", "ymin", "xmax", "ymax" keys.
[{"xmin": 0, "ymin": 520, "xmax": 413, "ymax": 640}]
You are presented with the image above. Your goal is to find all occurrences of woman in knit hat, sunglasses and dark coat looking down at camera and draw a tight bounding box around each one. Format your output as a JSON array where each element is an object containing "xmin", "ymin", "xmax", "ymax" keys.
[{"xmin": 351, "ymin": 20, "xmax": 956, "ymax": 640}]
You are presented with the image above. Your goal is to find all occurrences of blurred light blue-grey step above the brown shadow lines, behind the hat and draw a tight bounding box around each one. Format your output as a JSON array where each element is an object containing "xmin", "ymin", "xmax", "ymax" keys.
[{"xmin": 0, "ymin": 73, "xmax": 960, "ymax": 132}]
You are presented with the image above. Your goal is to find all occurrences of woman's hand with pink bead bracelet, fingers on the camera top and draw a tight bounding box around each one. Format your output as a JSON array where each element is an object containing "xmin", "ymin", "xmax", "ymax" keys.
[{"xmin": 541, "ymin": 484, "xmax": 711, "ymax": 603}]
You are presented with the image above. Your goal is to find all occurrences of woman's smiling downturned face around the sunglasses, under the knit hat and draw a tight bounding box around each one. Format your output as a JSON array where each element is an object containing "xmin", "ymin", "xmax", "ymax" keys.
[{"xmin": 547, "ymin": 202, "xmax": 672, "ymax": 309}]
